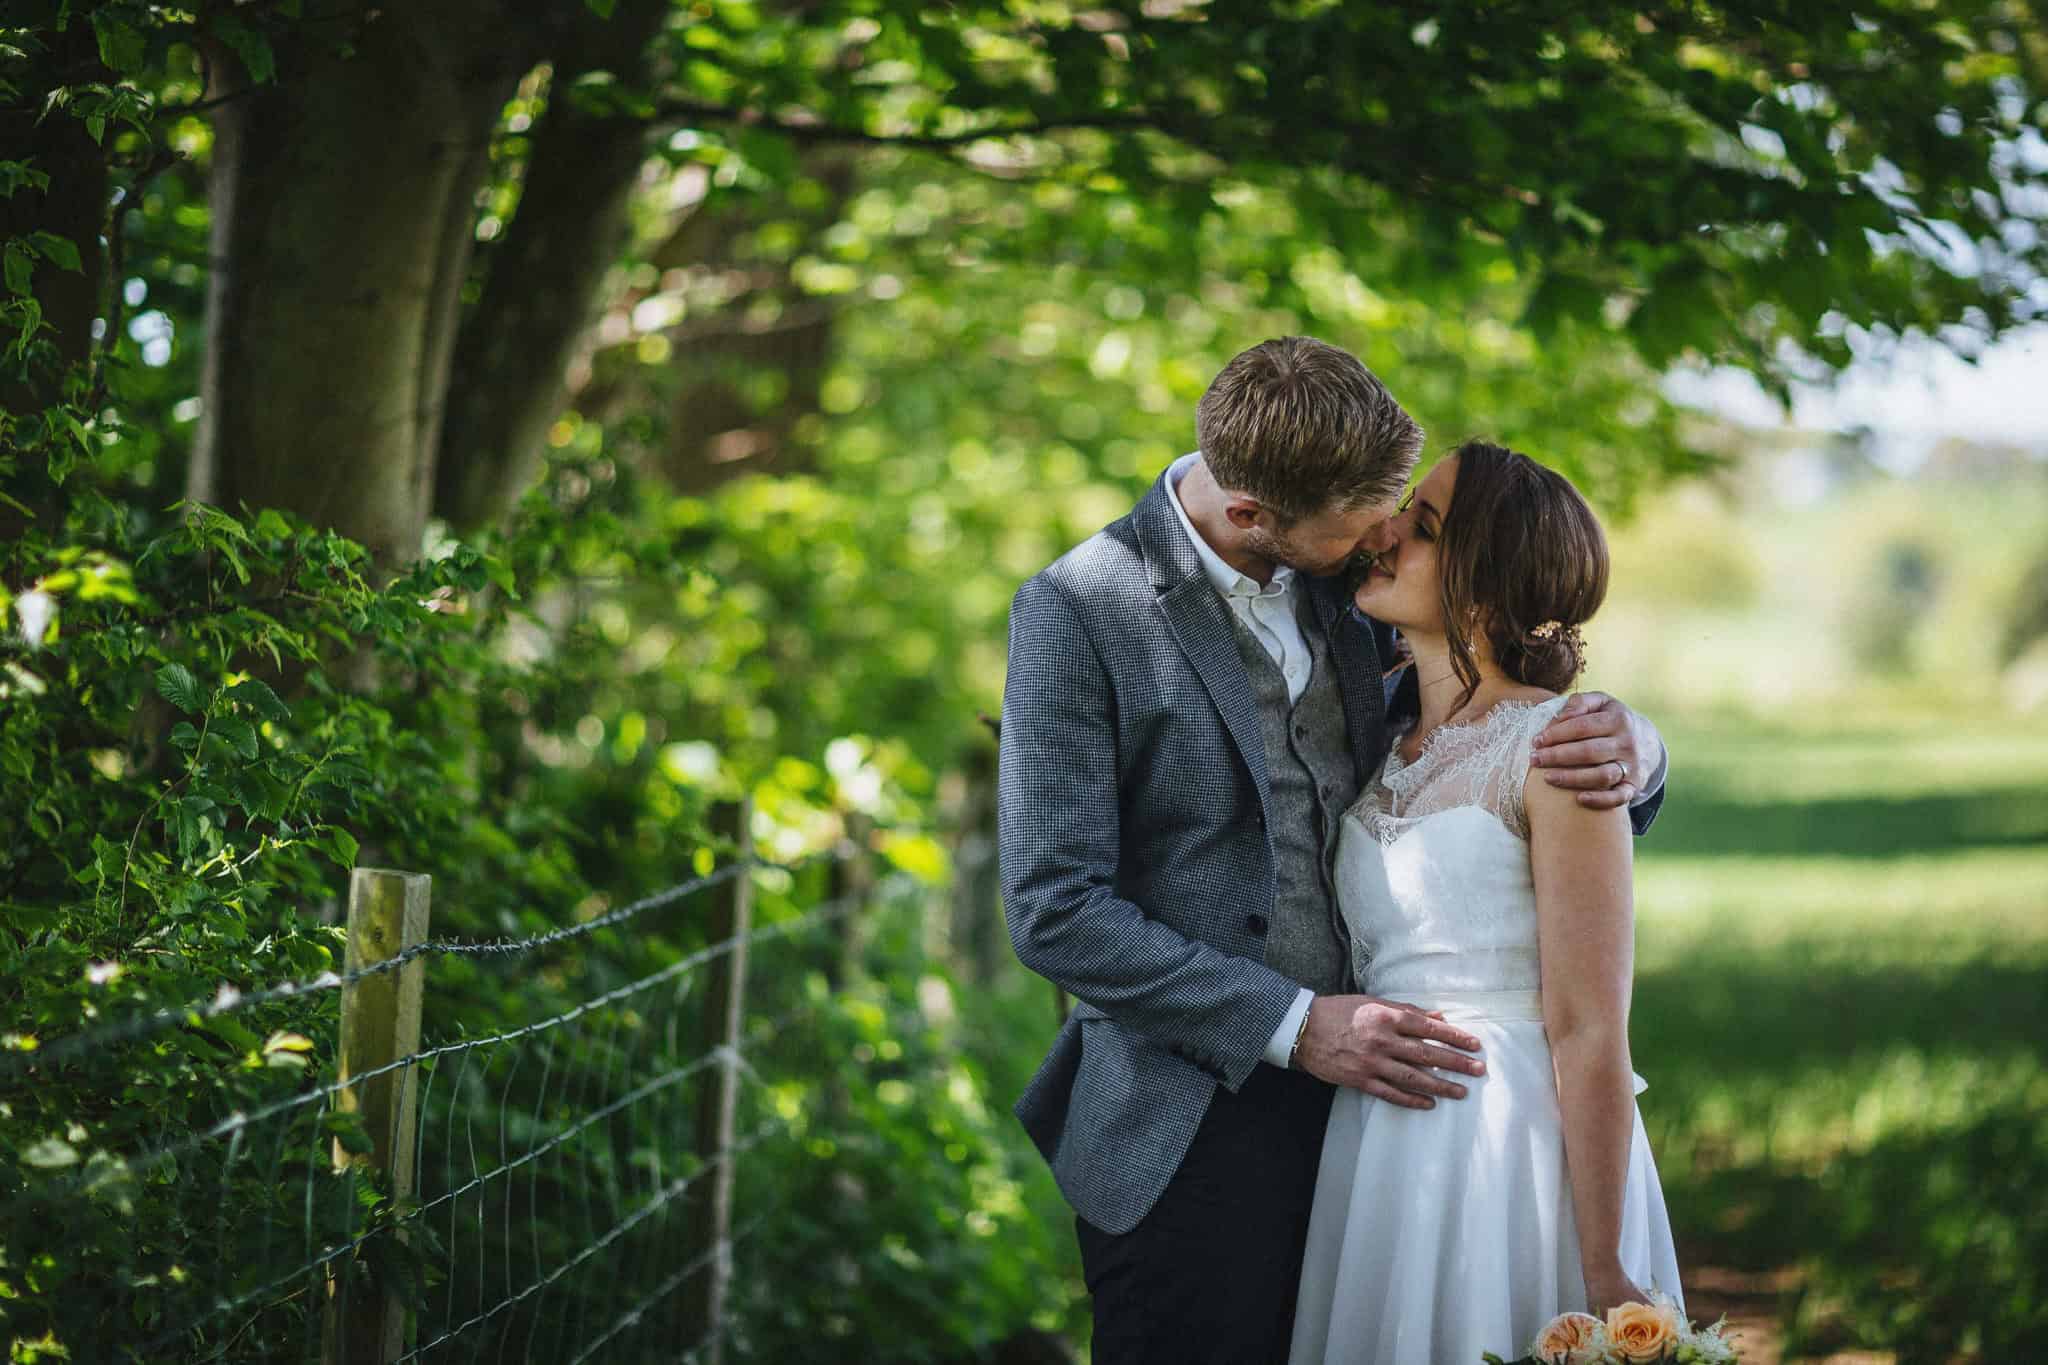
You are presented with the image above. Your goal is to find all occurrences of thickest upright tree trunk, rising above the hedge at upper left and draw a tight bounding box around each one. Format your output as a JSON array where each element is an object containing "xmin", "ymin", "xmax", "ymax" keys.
[{"xmin": 186, "ymin": 0, "xmax": 537, "ymax": 567}]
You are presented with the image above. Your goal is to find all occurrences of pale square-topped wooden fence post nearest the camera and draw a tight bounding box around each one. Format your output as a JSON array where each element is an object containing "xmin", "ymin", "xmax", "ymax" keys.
[{"xmin": 319, "ymin": 868, "xmax": 434, "ymax": 1365}]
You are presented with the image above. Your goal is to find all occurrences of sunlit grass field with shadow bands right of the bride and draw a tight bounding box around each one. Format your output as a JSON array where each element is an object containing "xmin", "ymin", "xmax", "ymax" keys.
[{"xmin": 1630, "ymin": 716, "xmax": 2048, "ymax": 1365}]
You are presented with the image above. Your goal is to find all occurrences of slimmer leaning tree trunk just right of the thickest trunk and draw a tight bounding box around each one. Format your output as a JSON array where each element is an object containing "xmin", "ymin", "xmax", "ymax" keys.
[{"xmin": 434, "ymin": 0, "xmax": 672, "ymax": 530}]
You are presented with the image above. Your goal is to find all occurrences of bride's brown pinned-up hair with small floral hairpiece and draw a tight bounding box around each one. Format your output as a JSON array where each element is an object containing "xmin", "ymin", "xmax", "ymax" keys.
[{"xmin": 1436, "ymin": 440, "xmax": 1608, "ymax": 714}]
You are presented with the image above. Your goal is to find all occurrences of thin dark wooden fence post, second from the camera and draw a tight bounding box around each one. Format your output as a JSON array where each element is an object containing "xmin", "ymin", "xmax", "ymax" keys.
[{"xmin": 678, "ymin": 800, "xmax": 754, "ymax": 1365}]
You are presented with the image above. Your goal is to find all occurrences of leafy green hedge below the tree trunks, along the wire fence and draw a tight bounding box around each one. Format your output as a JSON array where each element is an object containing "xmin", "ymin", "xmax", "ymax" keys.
[{"xmin": 0, "ymin": 444, "xmax": 1053, "ymax": 1359}]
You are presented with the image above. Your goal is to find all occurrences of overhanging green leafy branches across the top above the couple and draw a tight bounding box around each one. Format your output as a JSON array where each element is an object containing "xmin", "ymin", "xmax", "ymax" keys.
[{"xmin": 651, "ymin": 2, "xmax": 2044, "ymax": 394}]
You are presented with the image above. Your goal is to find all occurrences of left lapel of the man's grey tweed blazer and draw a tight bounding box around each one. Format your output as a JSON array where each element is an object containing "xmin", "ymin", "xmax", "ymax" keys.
[{"xmin": 1130, "ymin": 475, "xmax": 1272, "ymax": 808}]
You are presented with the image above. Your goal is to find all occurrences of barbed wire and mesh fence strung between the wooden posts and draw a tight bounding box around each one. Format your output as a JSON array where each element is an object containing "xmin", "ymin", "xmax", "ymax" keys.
[{"xmin": 4, "ymin": 855, "xmax": 888, "ymax": 1365}]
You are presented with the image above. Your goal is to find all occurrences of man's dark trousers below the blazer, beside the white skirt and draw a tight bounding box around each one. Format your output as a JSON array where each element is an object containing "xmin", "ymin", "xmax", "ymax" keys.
[{"xmin": 1073, "ymin": 1064, "xmax": 1335, "ymax": 1365}]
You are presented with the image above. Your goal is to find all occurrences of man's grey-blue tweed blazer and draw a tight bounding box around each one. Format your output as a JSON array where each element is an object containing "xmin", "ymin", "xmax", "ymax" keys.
[{"xmin": 997, "ymin": 475, "xmax": 1661, "ymax": 1234}]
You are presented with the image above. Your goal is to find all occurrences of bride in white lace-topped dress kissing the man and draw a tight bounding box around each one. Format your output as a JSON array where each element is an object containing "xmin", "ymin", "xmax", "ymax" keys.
[{"xmin": 1290, "ymin": 442, "xmax": 1683, "ymax": 1365}]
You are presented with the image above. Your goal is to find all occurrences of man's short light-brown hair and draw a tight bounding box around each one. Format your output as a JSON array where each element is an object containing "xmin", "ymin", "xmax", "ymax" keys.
[{"xmin": 1194, "ymin": 336, "xmax": 1421, "ymax": 522}]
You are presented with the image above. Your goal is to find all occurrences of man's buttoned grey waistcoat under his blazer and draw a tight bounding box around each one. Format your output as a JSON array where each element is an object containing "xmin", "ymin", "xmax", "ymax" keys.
[{"xmin": 1229, "ymin": 589, "xmax": 1358, "ymax": 995}]
